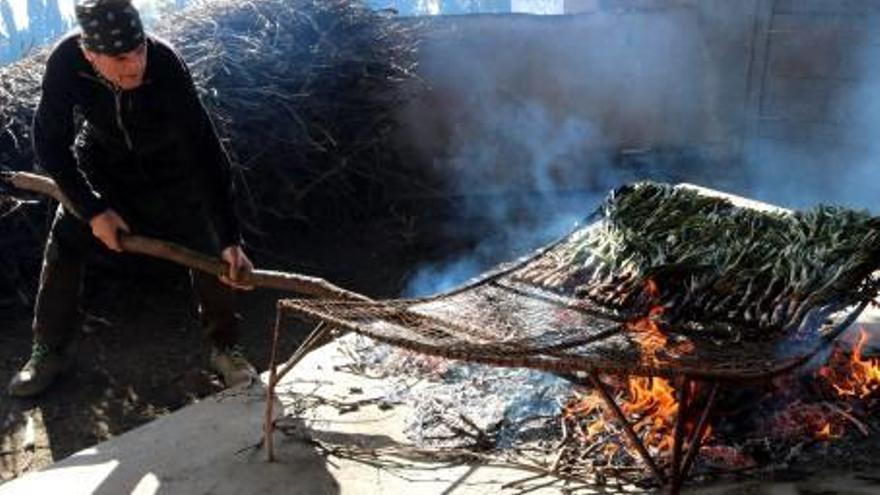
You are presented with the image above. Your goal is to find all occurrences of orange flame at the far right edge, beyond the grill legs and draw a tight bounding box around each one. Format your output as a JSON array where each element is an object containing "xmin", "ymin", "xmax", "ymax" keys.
[{"xmin": 819, "ymin": 328, "xmax": 880, "ymax": 399}]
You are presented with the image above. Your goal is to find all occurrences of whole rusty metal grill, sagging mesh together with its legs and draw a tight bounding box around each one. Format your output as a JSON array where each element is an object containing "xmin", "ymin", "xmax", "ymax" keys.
[{"xmin": 265, "ymin": 186, "xmax": 867, "ymax": 493}]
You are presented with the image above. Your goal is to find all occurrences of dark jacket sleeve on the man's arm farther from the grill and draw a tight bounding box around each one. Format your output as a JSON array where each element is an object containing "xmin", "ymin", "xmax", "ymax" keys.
[{"xmin": 32, "ymin": 46, "xmax": 107, "ymax": 221}]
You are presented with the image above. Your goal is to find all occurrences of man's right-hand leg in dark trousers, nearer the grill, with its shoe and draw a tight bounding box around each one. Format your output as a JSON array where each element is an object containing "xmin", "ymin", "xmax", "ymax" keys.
[{"xmin": 190, "ymin": 270, "xmax": 257, "ymax": 387}]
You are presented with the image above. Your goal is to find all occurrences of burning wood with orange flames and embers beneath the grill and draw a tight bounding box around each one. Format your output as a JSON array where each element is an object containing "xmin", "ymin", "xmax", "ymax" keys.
[{"xmin": 556, "ymin": 328, "xmax": 880, "ymax": 481}]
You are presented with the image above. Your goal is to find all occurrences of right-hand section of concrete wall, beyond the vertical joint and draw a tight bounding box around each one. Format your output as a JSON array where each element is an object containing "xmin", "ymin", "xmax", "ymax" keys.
[{"xmin": 744, "ymin": 0, "xmax": 880, "ymax": 207}]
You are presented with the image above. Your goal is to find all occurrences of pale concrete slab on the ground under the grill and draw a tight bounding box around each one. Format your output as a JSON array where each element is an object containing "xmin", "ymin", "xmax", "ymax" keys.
[{"xmin": 0, "ymin": 320, "xmax": 880, "ymax": 495}]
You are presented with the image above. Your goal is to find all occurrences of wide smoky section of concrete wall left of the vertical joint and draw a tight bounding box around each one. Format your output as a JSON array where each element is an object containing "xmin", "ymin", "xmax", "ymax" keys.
[{"xmin": 399, "ymin": 0, "xmax": 758, "ymax": 196}]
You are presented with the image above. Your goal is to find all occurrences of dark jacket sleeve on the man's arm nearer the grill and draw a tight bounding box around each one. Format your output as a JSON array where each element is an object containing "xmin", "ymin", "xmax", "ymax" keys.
[{"xmin": 172, "ymin": 48, "xmax": 241, "ymax": 249}]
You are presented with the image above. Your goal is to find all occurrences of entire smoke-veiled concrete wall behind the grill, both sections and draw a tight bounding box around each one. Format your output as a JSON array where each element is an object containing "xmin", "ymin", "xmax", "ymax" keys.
[{"xmin": 399, "ymin": 0, "xmax": 880, "ymax": 206}]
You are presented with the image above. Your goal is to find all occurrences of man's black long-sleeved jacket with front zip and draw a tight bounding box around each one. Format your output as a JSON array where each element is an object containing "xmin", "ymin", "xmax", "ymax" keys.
[{"xmin": 33, "ymin": 33, "xmax": 241, "ymax": 254}]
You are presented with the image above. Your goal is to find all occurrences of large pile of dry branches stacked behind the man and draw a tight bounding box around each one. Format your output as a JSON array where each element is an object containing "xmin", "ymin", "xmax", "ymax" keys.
[{"xmin": 0, "ymin": 0, "xmax": 418, "ymax": 302}]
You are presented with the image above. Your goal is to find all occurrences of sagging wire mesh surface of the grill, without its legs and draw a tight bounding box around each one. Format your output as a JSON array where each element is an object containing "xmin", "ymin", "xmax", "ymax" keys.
[{"xmin": 280, "ymin": 222, "xmax": 863, "ymax": 380}]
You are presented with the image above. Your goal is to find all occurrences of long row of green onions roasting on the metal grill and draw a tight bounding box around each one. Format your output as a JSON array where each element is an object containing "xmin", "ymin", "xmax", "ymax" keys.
[{"xmin": 544, "ymin": 183, "xmax": 880, "ymax": 338}]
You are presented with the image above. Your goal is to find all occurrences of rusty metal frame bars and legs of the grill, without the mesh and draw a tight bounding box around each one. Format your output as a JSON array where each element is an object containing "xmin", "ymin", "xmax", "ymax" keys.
[{"xmin": 264, "ymin": 185, "xmax": 867, "ymax": 493}]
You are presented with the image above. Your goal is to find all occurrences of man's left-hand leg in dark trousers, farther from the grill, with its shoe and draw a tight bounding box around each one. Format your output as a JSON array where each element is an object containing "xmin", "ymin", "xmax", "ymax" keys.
[{"xmin": 9, "ymin": 208, "xmax": 88, "ymax": 397}]
